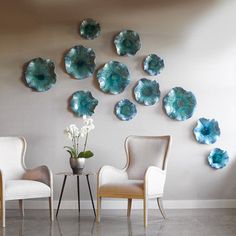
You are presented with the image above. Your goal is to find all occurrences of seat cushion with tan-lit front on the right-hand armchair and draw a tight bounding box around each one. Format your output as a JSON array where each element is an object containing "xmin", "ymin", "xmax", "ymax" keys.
[{"xmin": 99, "ymin": 180, "xmax": 144, "ymax": 198}]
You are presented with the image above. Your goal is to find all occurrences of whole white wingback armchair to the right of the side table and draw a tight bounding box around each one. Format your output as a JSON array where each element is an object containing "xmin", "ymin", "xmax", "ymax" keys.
[{"xmin": 97, "ymin": 136, "xmax": 171, "ymax": 227}]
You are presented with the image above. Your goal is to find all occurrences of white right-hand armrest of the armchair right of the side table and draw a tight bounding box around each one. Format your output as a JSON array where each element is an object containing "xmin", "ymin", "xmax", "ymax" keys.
[{"xmin": 144, "ymin": 166, "xmax": 166, "ymax": 197}]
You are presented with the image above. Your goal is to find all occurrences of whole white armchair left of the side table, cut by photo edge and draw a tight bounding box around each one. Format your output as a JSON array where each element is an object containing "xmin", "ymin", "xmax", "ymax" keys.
[{"xmin": 0, "ymin": 137, "xmax": 54, "ymax": 227}]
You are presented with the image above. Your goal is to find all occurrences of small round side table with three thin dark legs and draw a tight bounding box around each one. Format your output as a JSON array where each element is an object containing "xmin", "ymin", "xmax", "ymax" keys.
[{"xmin": 56, "ymin": 172, "xmax": 96, "ymax": 218}]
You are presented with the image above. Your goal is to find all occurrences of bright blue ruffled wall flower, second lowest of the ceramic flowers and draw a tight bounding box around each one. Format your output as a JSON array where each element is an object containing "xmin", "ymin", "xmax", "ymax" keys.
[{"xmin": 193, "ymin": 118, "xmax": 220, "ymax": 144}]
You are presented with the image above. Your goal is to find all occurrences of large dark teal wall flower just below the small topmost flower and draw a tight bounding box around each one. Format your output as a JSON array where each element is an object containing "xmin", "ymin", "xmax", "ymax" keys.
[{"xmin": 64, "ymin": 45, "xmax": 96, "ymax": 80}]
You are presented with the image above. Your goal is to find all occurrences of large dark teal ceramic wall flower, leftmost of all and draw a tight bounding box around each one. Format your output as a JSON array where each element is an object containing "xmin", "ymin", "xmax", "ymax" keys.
[{"xmin": 25, "ymin": 57, "xmax": 56, "ymax": 92}]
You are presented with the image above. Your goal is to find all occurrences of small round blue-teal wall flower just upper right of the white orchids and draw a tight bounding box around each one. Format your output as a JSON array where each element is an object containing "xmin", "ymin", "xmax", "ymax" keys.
[{"xmin": 115, "ymin": 99, "xmax": 137, "ymax": 121}]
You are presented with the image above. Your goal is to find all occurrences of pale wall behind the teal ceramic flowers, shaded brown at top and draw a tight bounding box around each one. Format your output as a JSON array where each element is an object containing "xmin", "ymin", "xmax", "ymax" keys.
[{"xmin": 0, "ymin": 0, "xmax": 236, "ymax": 200}]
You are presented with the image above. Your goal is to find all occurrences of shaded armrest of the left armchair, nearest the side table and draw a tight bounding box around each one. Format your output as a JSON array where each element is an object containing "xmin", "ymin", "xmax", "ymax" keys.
[{"xmin": 23, "ymin": 166, "xmax": 53, "ymax": 187}]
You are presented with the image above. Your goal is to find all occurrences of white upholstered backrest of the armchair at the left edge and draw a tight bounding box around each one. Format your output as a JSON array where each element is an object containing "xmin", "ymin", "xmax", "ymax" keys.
[{"xmin": 0, "ymin": 137, "xmax": 26, "ymax": 180}]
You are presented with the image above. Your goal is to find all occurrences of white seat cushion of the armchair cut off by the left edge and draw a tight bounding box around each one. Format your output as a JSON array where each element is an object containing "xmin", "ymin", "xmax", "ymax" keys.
[{"xmin": 5, "ymin": 180, "xmax": 51, "ymax": 200}]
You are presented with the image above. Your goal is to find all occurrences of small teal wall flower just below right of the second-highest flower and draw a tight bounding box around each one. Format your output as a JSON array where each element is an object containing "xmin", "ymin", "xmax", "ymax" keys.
[{"xmin": 143, "ymin": 54, "xmax": 164, "ymax": 75}]
